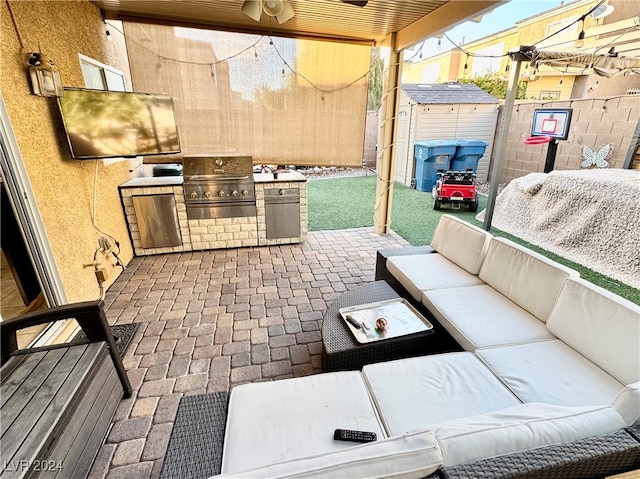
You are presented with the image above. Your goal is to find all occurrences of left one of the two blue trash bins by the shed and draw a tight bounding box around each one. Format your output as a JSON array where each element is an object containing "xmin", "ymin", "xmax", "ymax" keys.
[{"xmin": 413, "ymin": 140, "xmax": 458, "ymax": 191}]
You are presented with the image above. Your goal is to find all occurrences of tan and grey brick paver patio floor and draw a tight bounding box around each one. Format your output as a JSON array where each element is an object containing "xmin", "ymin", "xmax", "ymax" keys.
[{"xmin": 89, "ymin": 228, "xmax": 408, "ymax": 479}]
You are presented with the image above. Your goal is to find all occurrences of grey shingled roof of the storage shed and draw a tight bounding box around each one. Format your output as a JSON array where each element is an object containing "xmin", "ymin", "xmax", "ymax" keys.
[{"xmin": 402, "ymin": 83, "xmax": 500, "ymax": 105}]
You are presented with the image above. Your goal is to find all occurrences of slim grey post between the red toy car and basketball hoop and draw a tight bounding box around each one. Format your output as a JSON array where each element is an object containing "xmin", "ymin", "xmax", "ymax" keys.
[{"xmin": 483, "ymin": 56, "xmax": 522, "ymax": 231}]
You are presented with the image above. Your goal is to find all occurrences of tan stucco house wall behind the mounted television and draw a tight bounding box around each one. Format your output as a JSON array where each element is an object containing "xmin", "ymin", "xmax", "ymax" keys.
[{"xmin": 0, "ymin": 0, "xmax": 133, "ymax": 302}]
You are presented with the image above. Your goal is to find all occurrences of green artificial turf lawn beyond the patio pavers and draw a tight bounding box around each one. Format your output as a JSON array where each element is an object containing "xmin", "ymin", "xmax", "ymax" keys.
[{"xmin": 308, "ymin": 174, "xmax": 640, "ymax": 304}]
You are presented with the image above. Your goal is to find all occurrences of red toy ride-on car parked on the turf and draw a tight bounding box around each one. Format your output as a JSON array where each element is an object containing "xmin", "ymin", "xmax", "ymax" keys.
[{"xmin": 432, "ymin": 169, "xmax": 478, "ymax": 211}]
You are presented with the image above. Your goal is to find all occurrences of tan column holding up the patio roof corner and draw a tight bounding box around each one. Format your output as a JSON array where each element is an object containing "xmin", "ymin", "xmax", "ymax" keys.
[{"xmin": 373, "ymin": 33, "xmax": 402, "ymax": 234}]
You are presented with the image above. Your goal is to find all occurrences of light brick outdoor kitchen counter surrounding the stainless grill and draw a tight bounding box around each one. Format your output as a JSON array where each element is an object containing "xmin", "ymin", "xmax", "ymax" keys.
[{"xmin": 119, "ymin": 171, "xmax": 307, "ymax": 256}]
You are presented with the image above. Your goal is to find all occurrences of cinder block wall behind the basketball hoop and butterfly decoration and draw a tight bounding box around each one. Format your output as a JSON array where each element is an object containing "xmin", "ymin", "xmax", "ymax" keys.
[{"xmin": 496, "ymin": 96, "xmax": 640, "ymax": 183}]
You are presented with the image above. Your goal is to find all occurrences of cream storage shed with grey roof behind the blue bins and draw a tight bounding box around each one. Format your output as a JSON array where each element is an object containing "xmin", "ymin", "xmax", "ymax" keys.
[{"xmin": 394, "ymin": 83, "xmax": 500, "ymax": 186}]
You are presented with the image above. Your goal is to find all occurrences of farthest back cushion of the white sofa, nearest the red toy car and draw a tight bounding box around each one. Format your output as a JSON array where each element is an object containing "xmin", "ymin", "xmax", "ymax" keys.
[{"xmin": 431, "ymin": 215, "xmax": 492, "ymax": 274}]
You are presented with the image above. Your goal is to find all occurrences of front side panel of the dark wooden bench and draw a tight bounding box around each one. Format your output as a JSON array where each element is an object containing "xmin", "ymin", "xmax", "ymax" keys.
[{"xmin": 46, "ymin": 356, "xmax": 123, "ymax": 478}]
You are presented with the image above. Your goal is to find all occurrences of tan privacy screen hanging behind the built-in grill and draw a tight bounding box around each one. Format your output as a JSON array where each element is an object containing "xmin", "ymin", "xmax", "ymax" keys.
[{"xmin": 124, "ymin": 22, "xmax": 371, "ymax": 166}]
